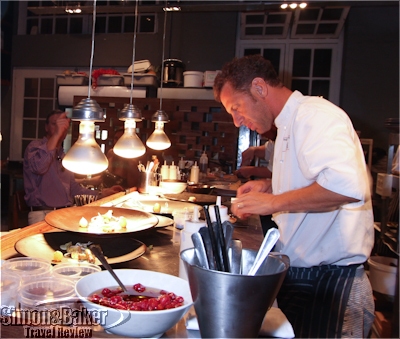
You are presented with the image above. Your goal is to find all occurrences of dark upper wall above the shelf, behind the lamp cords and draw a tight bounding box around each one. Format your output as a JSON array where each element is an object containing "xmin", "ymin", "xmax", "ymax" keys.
[{"xmin": 12, "ymin": 13, "xmax": 237, "ymax": 71}]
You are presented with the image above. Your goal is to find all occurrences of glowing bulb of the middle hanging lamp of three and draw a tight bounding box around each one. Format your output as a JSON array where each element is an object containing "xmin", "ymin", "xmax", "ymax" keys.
[{"xmin": 113, "ymin": 119, "xmax": 146, "ymax": 158}]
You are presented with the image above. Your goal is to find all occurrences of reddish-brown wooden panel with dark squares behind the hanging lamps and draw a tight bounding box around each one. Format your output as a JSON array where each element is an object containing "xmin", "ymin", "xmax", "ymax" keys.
[{"xmin": 72, "ymin": 97, "xmax": 239, "ymax": 169}]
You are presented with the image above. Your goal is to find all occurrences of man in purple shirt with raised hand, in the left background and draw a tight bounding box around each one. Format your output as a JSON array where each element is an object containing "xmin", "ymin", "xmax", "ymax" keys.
[{"xmin": 23, "ymin": 110, "xmax": 124, "ymax": 225}]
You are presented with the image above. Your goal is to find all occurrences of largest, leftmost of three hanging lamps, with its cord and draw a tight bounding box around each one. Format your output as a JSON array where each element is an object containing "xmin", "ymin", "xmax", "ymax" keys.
[{"xmin": 62, "ymin": 0, "xmax": 108, "ymax": 175}]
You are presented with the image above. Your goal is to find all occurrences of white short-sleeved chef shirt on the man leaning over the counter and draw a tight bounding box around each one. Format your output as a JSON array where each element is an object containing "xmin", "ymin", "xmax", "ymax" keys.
[{"xmin": 272, "ymin": 91, "xmax": 374, "ymax": 267}]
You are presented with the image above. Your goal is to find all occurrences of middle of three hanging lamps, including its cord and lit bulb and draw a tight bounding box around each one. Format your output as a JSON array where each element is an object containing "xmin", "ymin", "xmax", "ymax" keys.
[{"xmin": 113, "ymin": 0, "xmax": 146, "ymax": 158}]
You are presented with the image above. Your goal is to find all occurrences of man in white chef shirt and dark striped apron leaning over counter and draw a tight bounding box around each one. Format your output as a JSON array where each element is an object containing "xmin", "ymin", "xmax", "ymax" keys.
[{"xmin": 214, "ymin": 56, "xmax": 374, "ymax": 338}]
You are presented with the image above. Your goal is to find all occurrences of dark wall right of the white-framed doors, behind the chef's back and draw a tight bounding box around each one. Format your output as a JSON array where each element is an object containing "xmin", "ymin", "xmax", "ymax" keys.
[{"xmin": 340, "ymin": 3, "xmax": 399, "ymax": 150}]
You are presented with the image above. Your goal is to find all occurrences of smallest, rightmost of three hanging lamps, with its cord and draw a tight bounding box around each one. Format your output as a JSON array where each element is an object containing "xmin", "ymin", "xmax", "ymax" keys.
[{"xmin": 146, "ymin": 4, "xmax": 171, "ymax": 151}]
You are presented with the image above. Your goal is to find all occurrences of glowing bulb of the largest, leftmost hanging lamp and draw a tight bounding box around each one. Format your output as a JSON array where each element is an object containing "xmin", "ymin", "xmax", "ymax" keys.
[{"xmin": 62, "ymin": 121, "xmax": 108, "ymax": 175}]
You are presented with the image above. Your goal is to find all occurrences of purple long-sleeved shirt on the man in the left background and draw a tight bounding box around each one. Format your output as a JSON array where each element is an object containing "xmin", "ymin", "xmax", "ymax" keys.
[{"xmin": 24, "ymin": 137, "xmax": 99, "ymax": 207}]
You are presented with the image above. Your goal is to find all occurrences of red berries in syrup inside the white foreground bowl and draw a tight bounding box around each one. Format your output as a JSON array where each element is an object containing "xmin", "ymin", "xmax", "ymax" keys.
[{"xmin": 88, "ymin": 283, "xmax": 184, "ymax": 311}]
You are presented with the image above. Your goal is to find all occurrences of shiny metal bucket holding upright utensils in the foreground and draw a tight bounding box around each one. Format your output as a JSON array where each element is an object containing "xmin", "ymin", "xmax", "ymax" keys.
[{"xmin": 181, "ymin": 248, "xmax": 289, "ymax": 338}]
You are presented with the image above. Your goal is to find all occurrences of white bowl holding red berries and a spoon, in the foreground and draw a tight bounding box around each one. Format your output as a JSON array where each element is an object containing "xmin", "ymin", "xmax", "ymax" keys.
[{"xmin": 75, "ymin": 269, "xmax": 193, "ymax": 338}]
